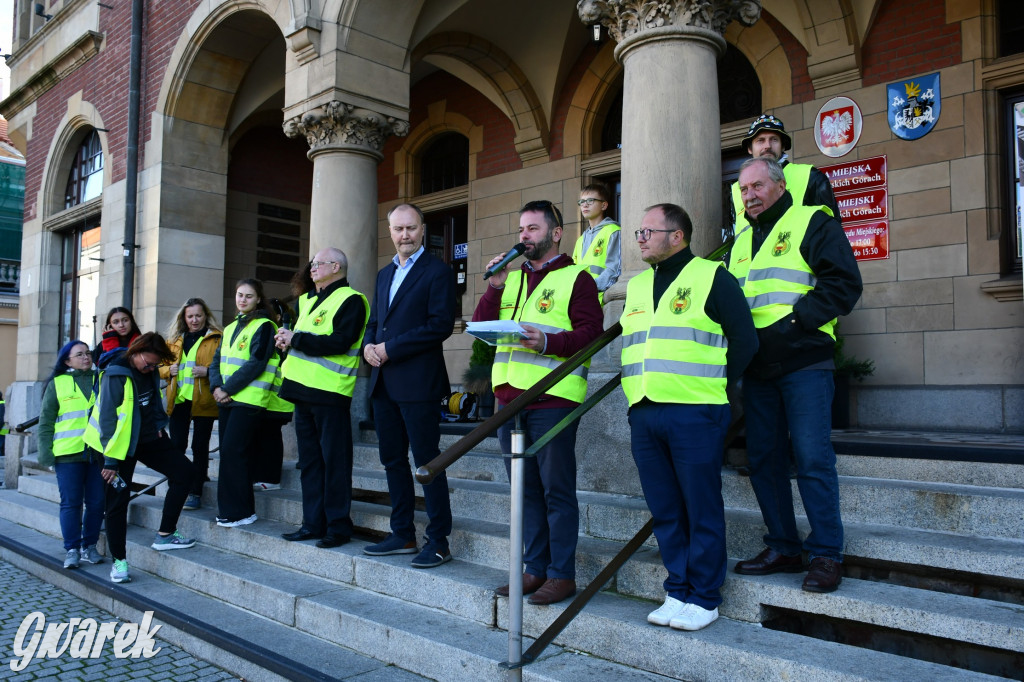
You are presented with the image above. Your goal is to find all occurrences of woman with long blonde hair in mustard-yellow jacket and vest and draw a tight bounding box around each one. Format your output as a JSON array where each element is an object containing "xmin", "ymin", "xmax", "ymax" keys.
[{"xmin": 160, "ymin": 298, "xmax": 221, "ymax": 510}]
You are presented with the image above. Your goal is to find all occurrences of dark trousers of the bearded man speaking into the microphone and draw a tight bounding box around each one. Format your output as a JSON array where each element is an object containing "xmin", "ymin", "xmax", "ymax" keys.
[{"xmin": 498, "ymin": 408, "xmax": 580, "ymax": 580}]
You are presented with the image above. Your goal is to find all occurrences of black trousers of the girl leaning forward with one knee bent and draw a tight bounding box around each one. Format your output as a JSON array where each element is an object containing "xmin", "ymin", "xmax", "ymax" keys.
[{"xmin": 106, "ymin": 432, "xmax": 196, "ymax": 559}]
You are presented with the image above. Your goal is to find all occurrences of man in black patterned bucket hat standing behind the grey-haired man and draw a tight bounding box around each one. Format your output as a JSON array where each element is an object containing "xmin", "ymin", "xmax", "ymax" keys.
[{"xmin": 732, "ymin": 114, "xmax": 840, "ymax": 228}]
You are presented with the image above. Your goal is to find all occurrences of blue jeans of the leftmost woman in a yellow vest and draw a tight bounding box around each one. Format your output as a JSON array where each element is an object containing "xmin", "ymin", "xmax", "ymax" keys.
[{"xmin": 53, "ymin": 457, "xmax": 106, "ymax": 550}]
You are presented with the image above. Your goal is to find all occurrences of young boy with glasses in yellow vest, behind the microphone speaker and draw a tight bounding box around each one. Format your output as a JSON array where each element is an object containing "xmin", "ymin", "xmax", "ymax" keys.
[{"xmin": 572, "ymin": 182, "xmax": 623, "ymax": 305}]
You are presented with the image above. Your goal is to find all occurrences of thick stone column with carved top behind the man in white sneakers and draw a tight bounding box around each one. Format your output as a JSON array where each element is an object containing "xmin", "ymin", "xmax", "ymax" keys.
[{"xmin": 577, "ymin": 0, "xmax": 761, "ymax": 274}]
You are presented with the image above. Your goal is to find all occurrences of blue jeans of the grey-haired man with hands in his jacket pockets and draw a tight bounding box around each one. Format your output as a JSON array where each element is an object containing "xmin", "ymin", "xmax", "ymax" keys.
[{"xmin": 743, "ymin": 370, "xmax": 843, "ymax": 561}]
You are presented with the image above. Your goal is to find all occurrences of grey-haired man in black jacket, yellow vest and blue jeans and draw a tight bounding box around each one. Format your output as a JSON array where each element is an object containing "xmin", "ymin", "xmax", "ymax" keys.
[{"xmin": 729, "ymin": 157, "xmax": 863, "ymax": 592}]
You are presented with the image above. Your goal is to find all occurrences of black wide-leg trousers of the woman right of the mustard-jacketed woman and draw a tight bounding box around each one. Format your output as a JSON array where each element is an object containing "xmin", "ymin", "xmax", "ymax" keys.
[{"xmin": 217, "ymin": 402, "xmax": 264, "ymax": 521}]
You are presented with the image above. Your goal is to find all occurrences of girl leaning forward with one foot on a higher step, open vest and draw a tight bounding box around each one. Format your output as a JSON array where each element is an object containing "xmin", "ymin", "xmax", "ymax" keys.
[{"xmin": 85, "ymin": 332, "xmax": 196, "ymax": 583}]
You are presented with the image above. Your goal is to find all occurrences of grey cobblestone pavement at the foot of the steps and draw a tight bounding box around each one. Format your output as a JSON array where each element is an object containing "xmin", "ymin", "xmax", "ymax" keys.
[{"xmin": 0, "ymin": 561, "xmax": 238, "ymax": 682}]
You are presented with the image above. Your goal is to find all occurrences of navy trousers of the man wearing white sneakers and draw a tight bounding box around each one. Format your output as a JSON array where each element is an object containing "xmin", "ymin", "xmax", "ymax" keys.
[{"xmin": 629, "ymin": 403, "xmax": 729, "ymax": 609}]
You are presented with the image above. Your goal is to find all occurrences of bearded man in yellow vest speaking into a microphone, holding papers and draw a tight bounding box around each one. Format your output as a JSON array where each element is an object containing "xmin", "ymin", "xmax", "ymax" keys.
[{"xmin": 473, "ymin": 201, "xmax": 603, "ymax": 604}]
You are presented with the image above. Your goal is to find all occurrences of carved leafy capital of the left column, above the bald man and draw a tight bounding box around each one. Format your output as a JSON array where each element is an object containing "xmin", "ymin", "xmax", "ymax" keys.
[{"xmin": 283, "ymin": 99, "xmax": 409, "ymax": 160}]
